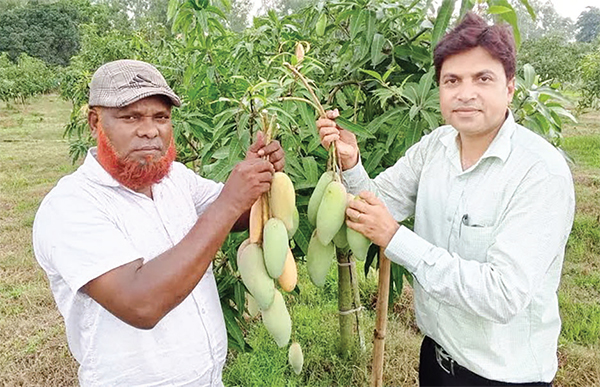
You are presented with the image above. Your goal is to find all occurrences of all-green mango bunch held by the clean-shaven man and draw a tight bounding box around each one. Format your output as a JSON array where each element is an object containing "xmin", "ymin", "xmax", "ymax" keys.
[{"xmin": 306, "ymin": 171, "xmax": 371, "ymax": 287}]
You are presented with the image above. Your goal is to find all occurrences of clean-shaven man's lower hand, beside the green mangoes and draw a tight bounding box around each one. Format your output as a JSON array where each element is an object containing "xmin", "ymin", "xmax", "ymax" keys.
[{"xmin": 346, "ymin": 191, "xmax": 400, "ymax": 248}]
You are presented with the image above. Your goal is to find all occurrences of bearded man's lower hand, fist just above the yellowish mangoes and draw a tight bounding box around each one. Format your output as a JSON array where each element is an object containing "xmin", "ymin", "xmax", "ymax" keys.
[{"xmin": 220, "ymin": 158, "xmax": 275, "ymax": 216}]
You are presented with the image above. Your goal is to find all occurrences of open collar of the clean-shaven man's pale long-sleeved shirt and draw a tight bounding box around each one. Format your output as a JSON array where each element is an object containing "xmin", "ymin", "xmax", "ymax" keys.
[{"xmin": 440, "ymin": 110, "xmax": 516, "ymax": 167}]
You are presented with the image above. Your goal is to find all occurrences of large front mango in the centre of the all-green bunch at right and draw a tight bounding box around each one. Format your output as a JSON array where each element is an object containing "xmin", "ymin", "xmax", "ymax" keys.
[{"xmin": 317, "ymin": 181, "xmax": 346, "ymax": 245}]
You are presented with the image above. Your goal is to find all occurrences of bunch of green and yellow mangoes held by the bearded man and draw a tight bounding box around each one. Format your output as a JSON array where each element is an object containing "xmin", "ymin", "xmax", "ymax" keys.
[{"xmin": 237, "ymin": 172, "xmax": 302, "ymax": 373}]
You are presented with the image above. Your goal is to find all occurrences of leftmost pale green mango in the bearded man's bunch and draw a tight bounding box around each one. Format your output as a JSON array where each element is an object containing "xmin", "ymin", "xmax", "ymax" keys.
[{"xmin": 237, "ymin": 243, "xmax": 276, "ymax": 310}]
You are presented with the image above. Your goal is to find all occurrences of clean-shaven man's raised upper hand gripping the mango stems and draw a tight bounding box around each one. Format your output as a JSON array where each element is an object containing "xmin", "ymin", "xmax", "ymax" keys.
[{"xmin": 317, "ymin": 109, "xmax": 358, "ymax": 171}]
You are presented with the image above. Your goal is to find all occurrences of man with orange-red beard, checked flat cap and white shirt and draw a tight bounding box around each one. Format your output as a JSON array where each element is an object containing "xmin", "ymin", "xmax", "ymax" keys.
[{"xmin": 33, "ymin": 60, "xmax": 284, "ymax": 386}]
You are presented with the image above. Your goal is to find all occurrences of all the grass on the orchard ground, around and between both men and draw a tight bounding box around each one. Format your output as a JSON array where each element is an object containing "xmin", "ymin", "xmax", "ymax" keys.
[{"xmin": 0, "ymin": 96, "xmax": 600, "ymax": 387}]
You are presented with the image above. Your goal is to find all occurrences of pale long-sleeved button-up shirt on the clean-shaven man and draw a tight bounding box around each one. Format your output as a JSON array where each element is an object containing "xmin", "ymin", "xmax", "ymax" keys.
[{"xmin": 343, "ymin": 114, "xmax": 575, "ymax": 383}]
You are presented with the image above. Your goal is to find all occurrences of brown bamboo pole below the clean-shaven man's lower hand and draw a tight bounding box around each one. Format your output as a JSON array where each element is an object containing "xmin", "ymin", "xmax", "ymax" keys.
[{"xmin": 371, "ymin": 248, "xmax": 391, "ymax": 387}]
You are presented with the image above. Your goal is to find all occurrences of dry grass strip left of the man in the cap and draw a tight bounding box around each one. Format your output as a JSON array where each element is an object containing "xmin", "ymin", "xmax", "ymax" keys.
[{"xmin": 0, "ymin": 96, "xmax": 77, "ymax": 386}]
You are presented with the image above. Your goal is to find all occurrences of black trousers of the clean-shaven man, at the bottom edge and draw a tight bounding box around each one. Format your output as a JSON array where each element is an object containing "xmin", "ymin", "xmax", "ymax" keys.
[{"xmin": 419, "ymin": 336, "xmax": 552, "ymax": 387}]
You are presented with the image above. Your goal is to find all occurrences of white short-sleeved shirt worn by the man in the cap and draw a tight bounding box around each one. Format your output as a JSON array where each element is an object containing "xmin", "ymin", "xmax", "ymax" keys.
[{"xmin": 33, "ymin": 149, "xmax": 227, "ymax": 387}]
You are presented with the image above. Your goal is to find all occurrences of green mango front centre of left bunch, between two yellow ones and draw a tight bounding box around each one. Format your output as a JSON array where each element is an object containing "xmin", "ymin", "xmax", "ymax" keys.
[{"xmin": 263, "ymin": 218, "xmax": 289, "ymax": 278}]
